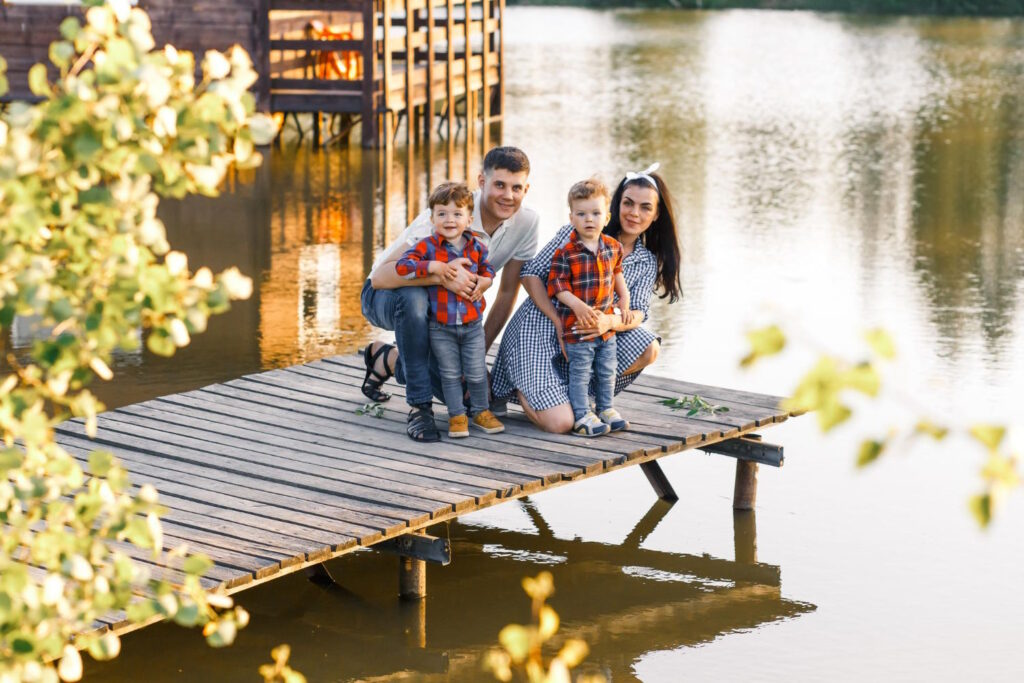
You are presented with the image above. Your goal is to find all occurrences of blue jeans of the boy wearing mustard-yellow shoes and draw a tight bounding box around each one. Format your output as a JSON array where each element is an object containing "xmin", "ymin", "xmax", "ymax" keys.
[{"xmin": 429, "ymin": 321, "xmax": 488, "ymax": 417}]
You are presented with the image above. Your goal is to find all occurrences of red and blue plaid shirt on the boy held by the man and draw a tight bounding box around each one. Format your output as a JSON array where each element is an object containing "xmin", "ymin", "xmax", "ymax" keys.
[{"xmin": 394, "ymin": 230, "xmax": 495, "ymax": 325}]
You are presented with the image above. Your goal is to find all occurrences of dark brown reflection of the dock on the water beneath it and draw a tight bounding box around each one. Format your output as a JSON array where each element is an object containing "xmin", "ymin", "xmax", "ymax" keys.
[{"xmin": 83, "ymin": 499, "xmax": 814, "ymax": 682}]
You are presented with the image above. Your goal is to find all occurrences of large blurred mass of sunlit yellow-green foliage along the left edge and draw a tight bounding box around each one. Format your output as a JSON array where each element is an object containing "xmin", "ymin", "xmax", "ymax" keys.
[{"xmin": 0, "ymin": 0, "xmax": 273, "ymax": 682}]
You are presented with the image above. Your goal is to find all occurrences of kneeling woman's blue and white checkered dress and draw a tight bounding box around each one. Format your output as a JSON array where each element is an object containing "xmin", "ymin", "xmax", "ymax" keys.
[{"xmin": 490, "ymin": 225, "xmax": 657, "ymax": 411}]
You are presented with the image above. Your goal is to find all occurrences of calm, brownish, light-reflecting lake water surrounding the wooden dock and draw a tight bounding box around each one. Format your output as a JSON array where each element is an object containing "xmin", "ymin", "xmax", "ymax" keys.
[{"xmin": 79, "ymin": 8, "xmax": 1024, "ymax": 681}]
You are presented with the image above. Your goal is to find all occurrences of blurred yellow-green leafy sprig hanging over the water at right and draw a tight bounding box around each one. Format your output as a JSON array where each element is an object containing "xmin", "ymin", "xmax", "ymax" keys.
[{"xmin": 740, "ymin": 325, "xmax": 1022, "ymax": 527}]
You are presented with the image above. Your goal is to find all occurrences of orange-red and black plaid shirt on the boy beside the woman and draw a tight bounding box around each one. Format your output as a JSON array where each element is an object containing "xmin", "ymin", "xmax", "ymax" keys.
[{"xmin": 548, "ymin": 230, "xmax": 623, "ymax": 344}]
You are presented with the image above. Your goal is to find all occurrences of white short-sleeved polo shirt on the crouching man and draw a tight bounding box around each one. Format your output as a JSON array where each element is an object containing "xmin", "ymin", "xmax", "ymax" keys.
[{"xmin": 370, "ymin": 189, "xmax": 541, "ymax": 276}]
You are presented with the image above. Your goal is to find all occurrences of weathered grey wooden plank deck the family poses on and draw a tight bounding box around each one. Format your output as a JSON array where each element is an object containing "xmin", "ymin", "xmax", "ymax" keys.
[{"xmin": 51, "ymin": 356, "xmax": 790, "ymax": 633}]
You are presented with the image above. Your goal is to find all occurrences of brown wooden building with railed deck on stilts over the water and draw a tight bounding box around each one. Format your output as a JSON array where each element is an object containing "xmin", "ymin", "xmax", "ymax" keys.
[{"xmin": 0, "ymin": 0, "xmax": 505, "ymax": 147}]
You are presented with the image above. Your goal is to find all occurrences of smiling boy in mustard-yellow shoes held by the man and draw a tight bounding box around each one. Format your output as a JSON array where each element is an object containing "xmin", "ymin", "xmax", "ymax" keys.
[{"xmin": 394, "ymin": 182, "xmax": 505, "ymax": 437}]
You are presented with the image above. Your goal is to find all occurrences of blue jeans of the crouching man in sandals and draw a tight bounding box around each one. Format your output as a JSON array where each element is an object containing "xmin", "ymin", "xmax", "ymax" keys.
[{"xmin": 359, "ymin": 279, "xmax": 442, "ymax": 405}]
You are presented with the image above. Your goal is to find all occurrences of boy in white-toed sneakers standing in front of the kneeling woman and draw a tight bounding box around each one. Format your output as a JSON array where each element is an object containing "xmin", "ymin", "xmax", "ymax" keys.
[{"xmin": 548, "ymin": 179, "xmax": 633, "ymax": 436}]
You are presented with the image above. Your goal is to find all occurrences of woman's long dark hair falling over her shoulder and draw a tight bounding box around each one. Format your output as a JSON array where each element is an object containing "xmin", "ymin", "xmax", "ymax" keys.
[{"xmin": 604, "ymin": 173, "xmax": 683, "ymax": 303}]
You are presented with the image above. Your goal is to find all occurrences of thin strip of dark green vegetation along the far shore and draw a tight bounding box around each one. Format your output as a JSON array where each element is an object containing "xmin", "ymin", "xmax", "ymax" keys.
[{"xmin": 508, "ymin": 0, "xmax": 1024, "ymax": 16}]
